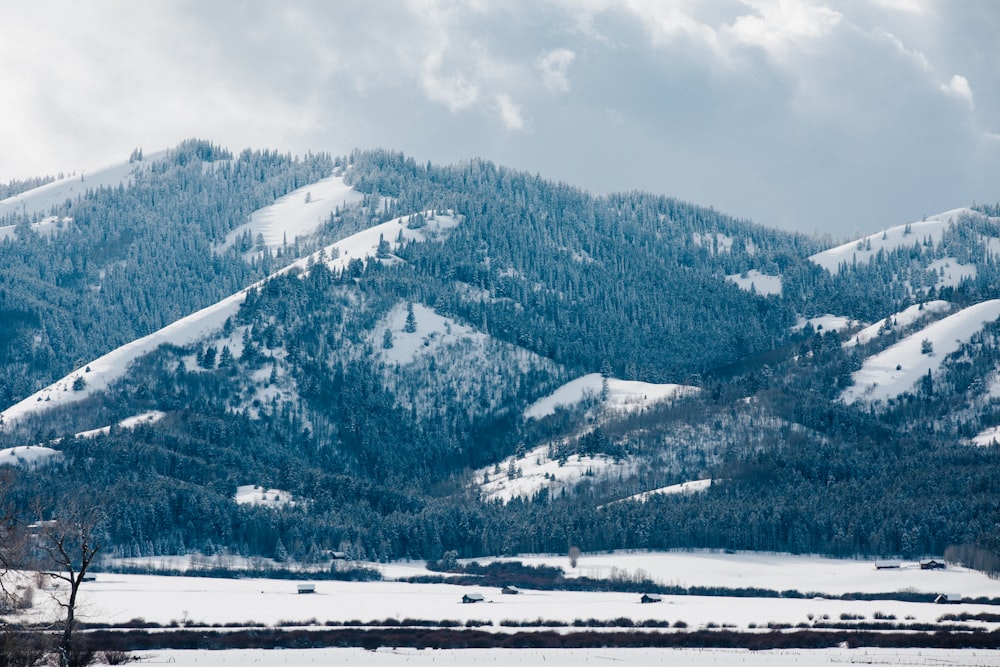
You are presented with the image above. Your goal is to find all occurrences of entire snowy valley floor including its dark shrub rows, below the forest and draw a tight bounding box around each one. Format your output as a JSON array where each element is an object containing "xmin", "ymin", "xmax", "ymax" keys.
[{"xmin": 11, "ymin": 551, "xmax": 1000, "ymax": 667}]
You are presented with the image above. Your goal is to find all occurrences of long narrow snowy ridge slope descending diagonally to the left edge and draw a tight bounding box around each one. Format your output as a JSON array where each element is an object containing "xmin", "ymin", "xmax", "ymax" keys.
[{"xmin": 0, "ymin": 213, "xmax": 460, "ymax": 426}]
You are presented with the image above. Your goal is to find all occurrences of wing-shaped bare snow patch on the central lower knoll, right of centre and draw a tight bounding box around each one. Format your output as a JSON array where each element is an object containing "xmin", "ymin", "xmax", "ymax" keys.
[{"xmin": 524, "ymin": 373, "xmax": 700, "ymax": 419}]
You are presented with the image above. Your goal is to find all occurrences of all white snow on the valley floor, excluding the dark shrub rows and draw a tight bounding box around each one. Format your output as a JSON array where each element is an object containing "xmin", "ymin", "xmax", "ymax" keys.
[{"xmin": 13, "ymin": 551, "xmax": 1000, "ymax": 666}]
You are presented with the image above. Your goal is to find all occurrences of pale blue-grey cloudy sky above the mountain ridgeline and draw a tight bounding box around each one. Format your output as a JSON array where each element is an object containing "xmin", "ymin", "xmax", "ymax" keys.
[{"xmin": 0, "ymin": 0, "xmax": 1000, "ymax": 238}]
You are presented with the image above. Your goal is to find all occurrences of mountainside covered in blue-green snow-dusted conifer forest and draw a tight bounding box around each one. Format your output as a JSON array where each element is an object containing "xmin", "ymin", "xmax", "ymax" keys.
[{"xmin": 0, "ymin": 142, "xmax": 1000, "ymax": 572}]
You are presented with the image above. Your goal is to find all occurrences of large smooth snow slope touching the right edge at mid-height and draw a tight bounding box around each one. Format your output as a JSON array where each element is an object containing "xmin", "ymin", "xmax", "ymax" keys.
[{"xmin": 840, "ymin": 299, "xmax": 1000, "ymax": 404}]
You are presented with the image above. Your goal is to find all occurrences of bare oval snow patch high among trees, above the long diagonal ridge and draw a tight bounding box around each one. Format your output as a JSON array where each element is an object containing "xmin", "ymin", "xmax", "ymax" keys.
[{"xmin": 222, "ymin": 175, "xmax": 364, "ymax": 250}]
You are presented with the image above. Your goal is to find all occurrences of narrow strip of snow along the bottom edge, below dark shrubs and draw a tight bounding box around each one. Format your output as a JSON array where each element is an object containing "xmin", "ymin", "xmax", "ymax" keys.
[{"xmin": 136, "ymin": 647, "xmax": 1000, "ymax": 667}]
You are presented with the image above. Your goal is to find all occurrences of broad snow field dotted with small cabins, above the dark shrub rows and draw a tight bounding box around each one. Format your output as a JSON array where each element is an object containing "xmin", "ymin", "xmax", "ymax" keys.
[{"xmin": 19, "ymin": 551, "xmax": 1000, "ymax": 629}]
